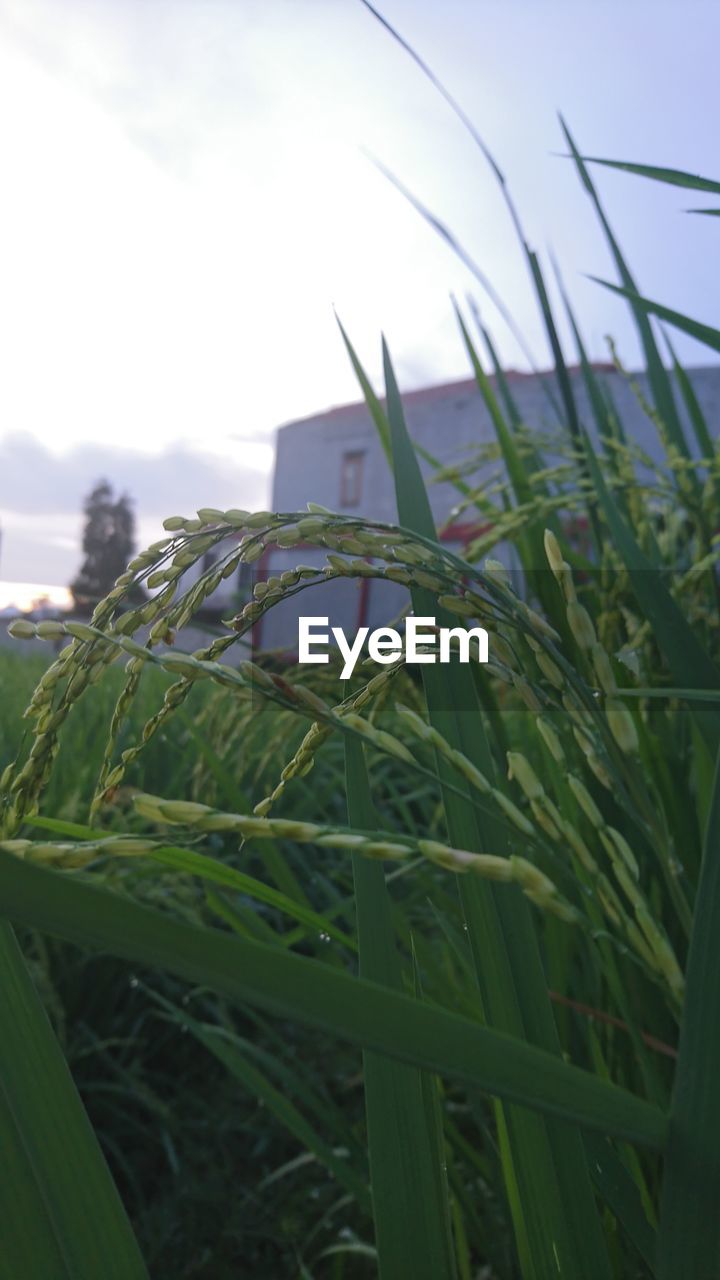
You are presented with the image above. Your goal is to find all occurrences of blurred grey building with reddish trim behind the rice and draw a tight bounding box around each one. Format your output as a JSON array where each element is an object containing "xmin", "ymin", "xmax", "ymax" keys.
[{"xmin": 249, "ymin": 365, "xmax": 720, "ymax": 649}]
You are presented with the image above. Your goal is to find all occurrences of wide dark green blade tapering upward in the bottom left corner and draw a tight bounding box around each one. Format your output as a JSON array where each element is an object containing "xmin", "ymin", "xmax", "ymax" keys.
[{"xmin": 0, "ymin": 920, "xmax": 147, "ymax": 1280}]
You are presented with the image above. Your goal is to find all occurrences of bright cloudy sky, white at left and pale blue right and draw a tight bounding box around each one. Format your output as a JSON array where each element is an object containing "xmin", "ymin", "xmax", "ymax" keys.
[{"xmin": 0, "ymin": 0, "xmax": 720, "ymax": 588}]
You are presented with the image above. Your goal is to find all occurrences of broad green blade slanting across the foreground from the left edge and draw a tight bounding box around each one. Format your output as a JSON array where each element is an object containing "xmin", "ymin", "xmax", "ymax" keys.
[{"xmin": 0, "ymin": 851, "xmax": 666, "ymax": 1148}]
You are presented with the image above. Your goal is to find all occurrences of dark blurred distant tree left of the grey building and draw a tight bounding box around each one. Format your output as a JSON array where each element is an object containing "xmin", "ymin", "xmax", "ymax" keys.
[{"xmin": 70, "ymin": 480, "xmax": 141, "ymax": 609}]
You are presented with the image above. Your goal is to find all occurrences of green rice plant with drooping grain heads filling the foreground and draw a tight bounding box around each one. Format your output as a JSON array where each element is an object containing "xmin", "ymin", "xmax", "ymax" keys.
[{"xmin": 0, "ymin": 49, "xmax": 720, "ymax": 1280}]
